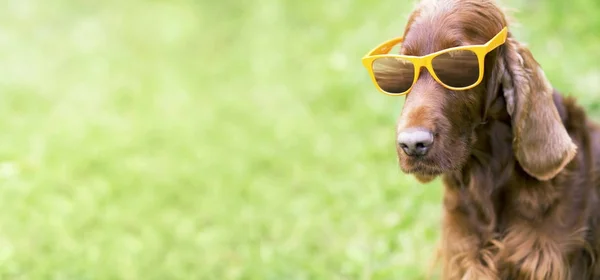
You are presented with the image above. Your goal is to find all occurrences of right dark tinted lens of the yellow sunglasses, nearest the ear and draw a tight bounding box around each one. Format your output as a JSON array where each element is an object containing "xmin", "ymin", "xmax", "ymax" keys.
[{"xmin": 431, "ymin": 50, "xmax": 479, "ymax": 88}]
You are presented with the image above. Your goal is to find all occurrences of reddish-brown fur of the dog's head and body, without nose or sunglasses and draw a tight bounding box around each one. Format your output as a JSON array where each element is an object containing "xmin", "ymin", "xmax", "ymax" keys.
[{"xmin": 397, "ymin": 0, "xmax": 600, "ymax": 280}]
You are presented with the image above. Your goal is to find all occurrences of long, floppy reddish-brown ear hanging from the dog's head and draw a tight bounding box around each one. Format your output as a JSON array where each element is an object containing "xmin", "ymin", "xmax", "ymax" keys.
[{"xmin": 490, "ymin": 37, "xmax": 577, "ymax": 180}]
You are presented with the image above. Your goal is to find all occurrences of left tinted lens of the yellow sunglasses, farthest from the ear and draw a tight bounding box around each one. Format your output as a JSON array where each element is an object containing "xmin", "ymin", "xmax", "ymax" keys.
[{"xmin": 373, "ymin": 57, "xmax": 415, "ymax": 94}]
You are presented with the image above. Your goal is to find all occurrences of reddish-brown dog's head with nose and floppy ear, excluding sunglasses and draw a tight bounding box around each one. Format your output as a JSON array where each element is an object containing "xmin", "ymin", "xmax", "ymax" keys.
[{"xmin": 397, "ymin": 0, "xmax": 576, "ymax": 182}]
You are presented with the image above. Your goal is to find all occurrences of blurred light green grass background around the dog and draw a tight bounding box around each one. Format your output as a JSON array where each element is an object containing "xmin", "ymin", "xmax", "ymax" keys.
[{"xmin": 0, "ymin": 0, "xmax": 600, "ymax": 280}]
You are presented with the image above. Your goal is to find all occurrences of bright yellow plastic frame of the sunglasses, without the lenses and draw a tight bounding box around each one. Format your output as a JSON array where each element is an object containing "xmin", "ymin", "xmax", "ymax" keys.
[{"xmin": 362, "ymin": 27, "xmax": 508, "ymax": 96}]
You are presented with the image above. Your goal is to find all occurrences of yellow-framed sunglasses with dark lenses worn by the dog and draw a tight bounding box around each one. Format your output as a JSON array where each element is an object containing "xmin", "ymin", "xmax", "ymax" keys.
[{"xmin": 362, "ymin": 27, "xmax": 508, "ymax": 95}]
